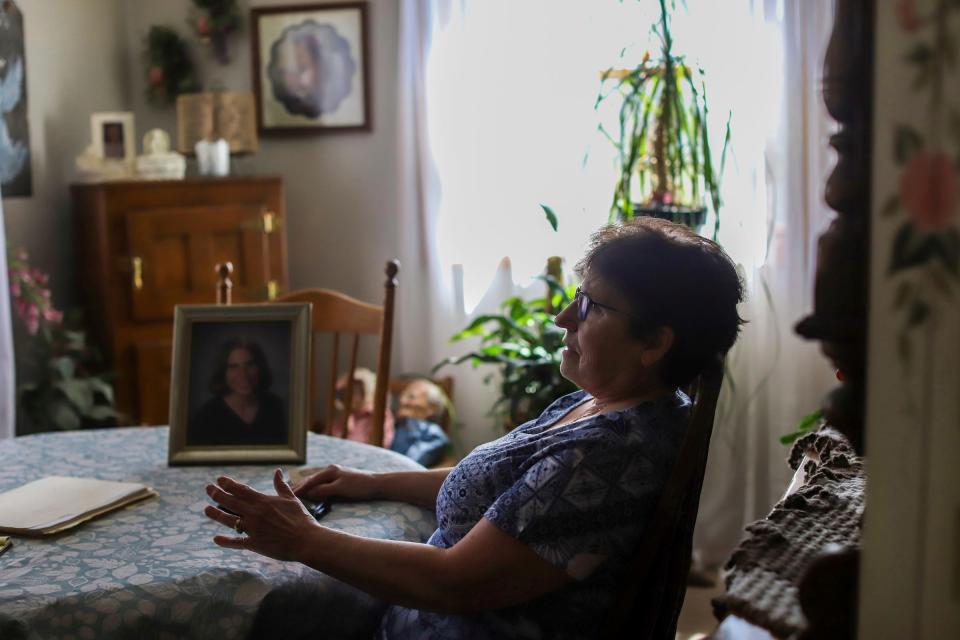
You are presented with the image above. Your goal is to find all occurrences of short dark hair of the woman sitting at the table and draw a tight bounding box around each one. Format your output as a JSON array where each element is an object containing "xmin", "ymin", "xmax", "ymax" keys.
[{"xmin": 576, "ymin": 217, "xmax": 744, "ymax": 387}]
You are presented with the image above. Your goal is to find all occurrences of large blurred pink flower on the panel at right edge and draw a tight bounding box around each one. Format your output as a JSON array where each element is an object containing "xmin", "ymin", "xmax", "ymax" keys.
[{"xmin": 900, "ymin": 151, "xmax": 957, "ymax": 231}]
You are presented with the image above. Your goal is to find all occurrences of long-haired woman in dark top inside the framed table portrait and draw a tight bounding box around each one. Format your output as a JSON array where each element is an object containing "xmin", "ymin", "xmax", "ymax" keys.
[{"xmin": 187, "ymin": 337, "xmax": 287, "ymax": 445}]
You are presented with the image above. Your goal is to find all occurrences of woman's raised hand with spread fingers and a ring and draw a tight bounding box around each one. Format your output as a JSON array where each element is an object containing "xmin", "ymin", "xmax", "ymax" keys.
[{"xmin": 204, "ymin": 469, "xmax": 320, "ymax": 560}]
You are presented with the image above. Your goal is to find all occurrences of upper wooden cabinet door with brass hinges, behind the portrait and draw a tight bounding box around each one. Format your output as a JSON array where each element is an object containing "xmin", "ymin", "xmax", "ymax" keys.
[{"xmin": 126, "ymin": 204, "xmax": 282, "ymax": 320}]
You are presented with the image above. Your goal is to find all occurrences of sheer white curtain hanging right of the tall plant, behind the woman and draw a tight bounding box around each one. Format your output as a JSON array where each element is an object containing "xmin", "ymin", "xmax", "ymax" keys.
[{"xmin": 690, "ymin": 0, "xmax": 836, "ymax": 564}]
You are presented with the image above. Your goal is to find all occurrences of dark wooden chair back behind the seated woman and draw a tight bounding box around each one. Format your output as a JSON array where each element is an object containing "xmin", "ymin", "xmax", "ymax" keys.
[{"xmin": 604, "ymin": 359, "xmax": 723, "ymax": 640}]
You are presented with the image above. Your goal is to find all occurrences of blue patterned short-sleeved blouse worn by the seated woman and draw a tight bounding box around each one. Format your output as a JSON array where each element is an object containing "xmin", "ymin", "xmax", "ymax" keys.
[{"xmin": 377, "ymin": 391, "xmax": 690, "ymax": 640}]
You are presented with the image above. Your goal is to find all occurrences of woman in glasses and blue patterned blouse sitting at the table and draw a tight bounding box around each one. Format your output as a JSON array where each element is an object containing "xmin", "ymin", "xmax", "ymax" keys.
[{"xmin": 206, "ymin": 218, "xmax": 742, "ymax": 638}]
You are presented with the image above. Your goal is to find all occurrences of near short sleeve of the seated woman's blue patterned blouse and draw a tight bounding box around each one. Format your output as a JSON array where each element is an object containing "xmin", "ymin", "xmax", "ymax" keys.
[{"xmin": 484, "ymin": 417, "xmax": 675, "ymax": 580}]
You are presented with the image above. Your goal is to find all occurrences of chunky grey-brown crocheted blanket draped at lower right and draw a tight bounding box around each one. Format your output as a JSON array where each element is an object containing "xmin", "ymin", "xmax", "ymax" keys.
[{"xmin": 713, "ymin": 427, "xmax": 866, "ymax": 639}]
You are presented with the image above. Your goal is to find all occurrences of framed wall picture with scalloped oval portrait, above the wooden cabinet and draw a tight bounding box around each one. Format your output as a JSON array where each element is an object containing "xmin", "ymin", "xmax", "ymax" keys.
[{"xmin": 250, "ymin": 2, "xmax": 370, "ymax": 134}]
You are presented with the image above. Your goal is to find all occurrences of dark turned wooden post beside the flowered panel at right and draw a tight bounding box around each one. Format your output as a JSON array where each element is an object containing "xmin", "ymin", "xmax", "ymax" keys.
[{"xmin": 796, "ymin": 0, "xmax": 876, "ymax": 638}]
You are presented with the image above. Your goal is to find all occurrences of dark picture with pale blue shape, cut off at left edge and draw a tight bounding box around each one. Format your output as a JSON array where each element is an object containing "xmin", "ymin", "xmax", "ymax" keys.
[{"xmin": 0, "ymin": 0, "xmax": 33, "ymax": 198}]
